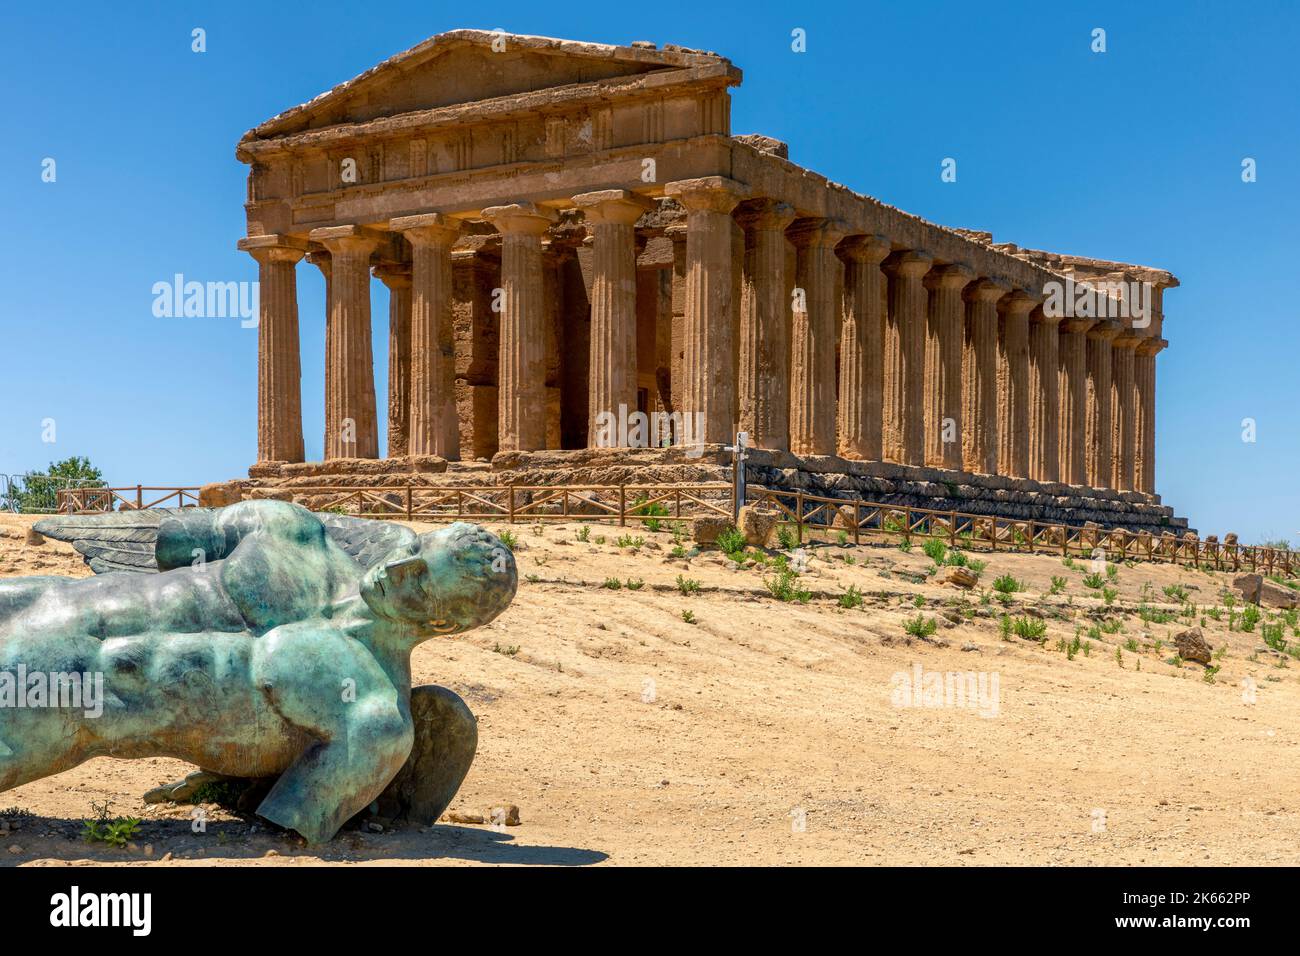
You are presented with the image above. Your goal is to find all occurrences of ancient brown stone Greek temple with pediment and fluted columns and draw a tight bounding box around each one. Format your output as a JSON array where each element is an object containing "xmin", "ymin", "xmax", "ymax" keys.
[{"xmin": 238, "ymin": 30, "xmax": 1178, "ymax": 493}]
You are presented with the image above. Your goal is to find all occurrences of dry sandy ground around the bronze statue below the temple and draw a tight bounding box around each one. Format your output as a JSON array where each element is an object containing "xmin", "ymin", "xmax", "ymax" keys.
[{"xmin": 0, "ymin": 516, "xmax": 1300, "ymax": 865}]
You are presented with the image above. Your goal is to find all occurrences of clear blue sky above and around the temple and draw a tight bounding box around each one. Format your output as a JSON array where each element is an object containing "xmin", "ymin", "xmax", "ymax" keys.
[{"xmin": 0, "ymin": 0, "xmax": 1300, "ymax": 540}]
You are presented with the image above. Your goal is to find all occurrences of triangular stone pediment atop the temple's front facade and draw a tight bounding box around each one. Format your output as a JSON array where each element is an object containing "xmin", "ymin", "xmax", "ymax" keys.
[{"xmin": 242, "ymin": 30, "xmax": 740, "ymax": 143}]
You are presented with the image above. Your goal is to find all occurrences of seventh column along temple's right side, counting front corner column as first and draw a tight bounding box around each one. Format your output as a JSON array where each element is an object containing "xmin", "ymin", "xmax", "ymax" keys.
[{"xmin": 962, "ymin": 278, "xmax": 1009, "ymax": 475}]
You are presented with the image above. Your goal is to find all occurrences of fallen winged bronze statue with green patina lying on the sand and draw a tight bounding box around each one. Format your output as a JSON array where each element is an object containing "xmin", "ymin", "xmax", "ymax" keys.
[{"xmin": 0, "ymin": 501, "xmax": 517, "ymax": 843}]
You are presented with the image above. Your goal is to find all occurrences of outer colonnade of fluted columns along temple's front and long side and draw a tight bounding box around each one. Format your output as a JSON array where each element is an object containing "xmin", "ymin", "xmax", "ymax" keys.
[{"xmin": 241, "ymin": 177, "xmax": 1164, "ymax": 492}]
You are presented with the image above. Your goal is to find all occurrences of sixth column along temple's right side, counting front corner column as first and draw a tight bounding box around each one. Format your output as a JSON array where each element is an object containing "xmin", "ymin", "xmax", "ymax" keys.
[{"xmin": 920, "ymin": 265, "xmax": 975, "ymax": 470}]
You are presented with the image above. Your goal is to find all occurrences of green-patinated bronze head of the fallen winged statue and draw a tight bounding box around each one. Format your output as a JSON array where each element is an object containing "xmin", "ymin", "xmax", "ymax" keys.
[{"xmin": 361, "ymin": 522, "xmax": 519, "ymax": 640}]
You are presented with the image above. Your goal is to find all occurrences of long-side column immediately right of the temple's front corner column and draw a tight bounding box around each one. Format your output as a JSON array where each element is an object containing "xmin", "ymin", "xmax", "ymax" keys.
[{"xmin": 736, "ymin": 199, "xmax": 794, "ymax": 451}]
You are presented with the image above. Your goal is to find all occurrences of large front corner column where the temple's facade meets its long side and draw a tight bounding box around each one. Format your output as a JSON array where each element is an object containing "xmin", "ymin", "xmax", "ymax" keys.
[{"xmin": 664, "ymin": 176, "xmax": 745, "ymax": 444}]
